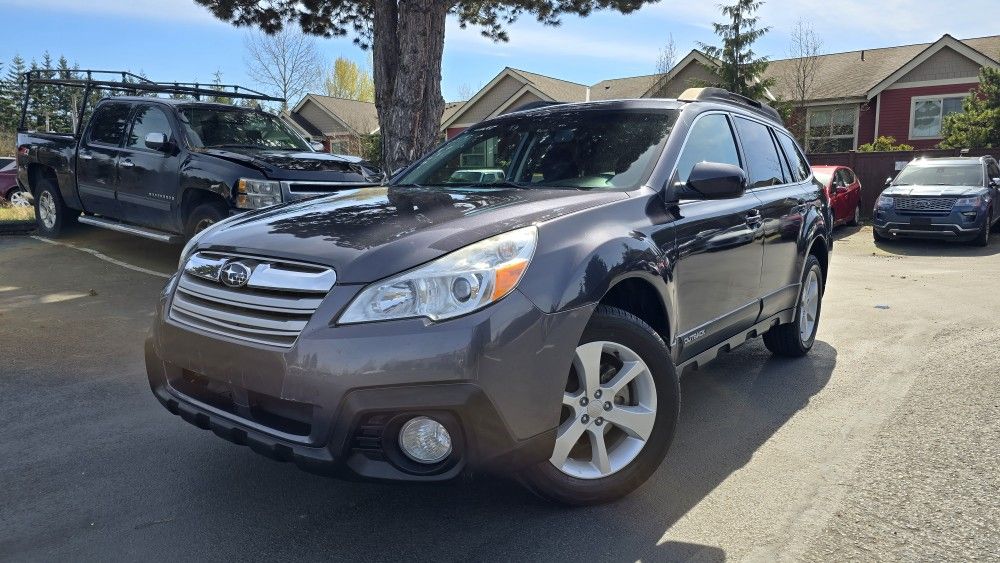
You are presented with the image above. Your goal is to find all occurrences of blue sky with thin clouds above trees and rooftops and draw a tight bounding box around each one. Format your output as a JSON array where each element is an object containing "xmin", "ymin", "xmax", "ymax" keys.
[{"xmin": 0, "ymin": 0, "xmax": 1000, "ymax": 100}]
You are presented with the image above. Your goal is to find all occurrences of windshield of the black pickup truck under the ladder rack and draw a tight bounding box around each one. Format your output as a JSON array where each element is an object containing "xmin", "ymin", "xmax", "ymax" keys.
[{"xmin": 180, "ymin": 107, "xmax": 312, "ymax": 151}]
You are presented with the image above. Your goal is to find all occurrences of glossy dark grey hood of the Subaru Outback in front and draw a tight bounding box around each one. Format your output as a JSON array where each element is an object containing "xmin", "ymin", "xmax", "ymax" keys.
[{"xmin": 198, "ymin": 186, "xmax": 628, "ymax": 284}]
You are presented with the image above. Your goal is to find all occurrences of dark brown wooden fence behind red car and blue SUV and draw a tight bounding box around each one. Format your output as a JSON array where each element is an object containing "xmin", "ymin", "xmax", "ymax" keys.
[{"xmin": 809, "ymin": 149, "xmax": 1000, "ymax": 217}]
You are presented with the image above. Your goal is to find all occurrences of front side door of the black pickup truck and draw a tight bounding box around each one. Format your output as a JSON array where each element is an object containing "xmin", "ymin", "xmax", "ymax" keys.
[{"xmin": 118, "ymin": 104, "xmax": 181, "ymax": 230}]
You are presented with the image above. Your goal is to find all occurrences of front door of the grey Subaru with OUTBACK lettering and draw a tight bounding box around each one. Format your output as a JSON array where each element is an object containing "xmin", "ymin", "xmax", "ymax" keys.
[{"xmin": 672, "ymin": 113, "xmax": 763, "ymax": 361}]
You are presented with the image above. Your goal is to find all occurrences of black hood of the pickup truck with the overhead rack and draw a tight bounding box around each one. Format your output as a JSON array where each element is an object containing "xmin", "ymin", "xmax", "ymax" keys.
[{"xmin": 198, "ymin": 148, "xmax": 379, "ymax": 183}]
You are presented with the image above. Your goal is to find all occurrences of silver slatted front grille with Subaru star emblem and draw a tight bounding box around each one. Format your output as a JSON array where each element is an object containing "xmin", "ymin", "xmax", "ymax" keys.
[{"xmin": 170, "ymin": 252, "xmax": 336, "ymax": 348}]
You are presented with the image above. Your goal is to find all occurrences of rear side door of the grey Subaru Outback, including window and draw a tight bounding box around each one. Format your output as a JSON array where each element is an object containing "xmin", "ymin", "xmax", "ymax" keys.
[{"xmin": 736, "ymin": 117, "xmax": 819, "ymax": 319}]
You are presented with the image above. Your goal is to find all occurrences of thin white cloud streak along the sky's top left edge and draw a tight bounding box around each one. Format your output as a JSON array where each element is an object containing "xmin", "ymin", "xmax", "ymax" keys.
[{"xmin": 0, "ymin": 0, "xmax": 221, "ymax": 24}]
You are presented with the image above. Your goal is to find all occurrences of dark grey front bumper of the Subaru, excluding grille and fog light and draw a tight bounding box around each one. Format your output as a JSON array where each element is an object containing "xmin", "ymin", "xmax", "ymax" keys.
[{"xmin": 146, "ymin": 282, "xmax": 593, "ymax": 481}]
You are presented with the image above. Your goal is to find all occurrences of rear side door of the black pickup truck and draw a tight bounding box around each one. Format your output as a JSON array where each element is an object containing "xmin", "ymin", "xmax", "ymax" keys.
[{"xmin": 76, "ymin": 102, "xmax": 132, "ymax": 219}]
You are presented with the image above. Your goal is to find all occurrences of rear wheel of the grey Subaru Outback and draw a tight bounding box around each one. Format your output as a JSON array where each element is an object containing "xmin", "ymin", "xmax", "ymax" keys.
[{"xmin": 764, "ymin": 254, "xmax": 823, "ymax": 357}]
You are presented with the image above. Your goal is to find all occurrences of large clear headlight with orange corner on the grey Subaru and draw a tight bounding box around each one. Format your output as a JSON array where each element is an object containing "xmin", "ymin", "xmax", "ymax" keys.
[{"xmin": 339, "ymin": 227, "xmax": 538, "ymax": 324}]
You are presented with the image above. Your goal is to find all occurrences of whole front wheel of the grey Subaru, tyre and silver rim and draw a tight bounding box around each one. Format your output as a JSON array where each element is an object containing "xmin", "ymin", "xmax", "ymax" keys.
[{"xmin": 521, "ymin": 306, "xmax": 680, "ymax": 505}]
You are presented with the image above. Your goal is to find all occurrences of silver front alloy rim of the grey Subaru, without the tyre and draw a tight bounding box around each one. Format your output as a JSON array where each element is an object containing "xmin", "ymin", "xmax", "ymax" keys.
[{"xmin": 549, "ymin": 341, "xmax": 656, "ymax": 479}]
